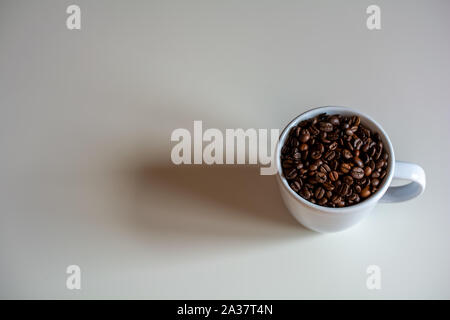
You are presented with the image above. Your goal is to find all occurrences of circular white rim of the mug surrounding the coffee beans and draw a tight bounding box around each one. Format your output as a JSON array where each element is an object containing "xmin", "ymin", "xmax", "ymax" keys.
[{"xmin": 276, "ymin": 106, "xmax": 395, "ymax": 214}]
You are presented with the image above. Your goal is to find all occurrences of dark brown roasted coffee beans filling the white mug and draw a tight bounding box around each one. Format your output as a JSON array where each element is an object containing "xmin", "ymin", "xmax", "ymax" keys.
[{"xmin": 281, "ymin": 113, "xmax": 389, "ymax": 208}]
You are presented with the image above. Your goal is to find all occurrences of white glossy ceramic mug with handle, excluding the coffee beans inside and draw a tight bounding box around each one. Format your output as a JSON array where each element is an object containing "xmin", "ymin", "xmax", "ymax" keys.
[{"xmin": 275, "ymin": 106, "xmax": 425, "ymax": 233}]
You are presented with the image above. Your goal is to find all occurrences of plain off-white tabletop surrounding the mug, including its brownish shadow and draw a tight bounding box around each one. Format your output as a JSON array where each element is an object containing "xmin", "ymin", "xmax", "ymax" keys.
[{"xmin": 0, "ymin": 0, "xmax": 450, "ymax": 299}]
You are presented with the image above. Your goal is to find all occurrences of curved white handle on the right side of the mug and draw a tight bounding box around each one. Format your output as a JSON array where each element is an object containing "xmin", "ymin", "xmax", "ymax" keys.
[{"xmin": 380, "ymin": 161, "xmax": 426, "ymax": 203}]
